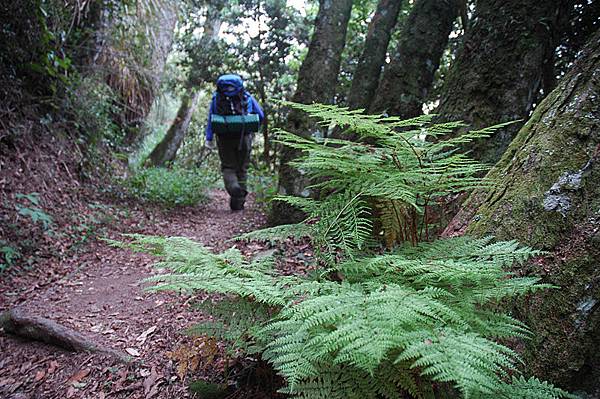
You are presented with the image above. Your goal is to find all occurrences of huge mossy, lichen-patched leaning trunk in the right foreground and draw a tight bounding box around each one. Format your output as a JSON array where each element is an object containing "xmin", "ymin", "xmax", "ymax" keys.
[{"xmin": 446, "ymin": 30, "xmax": 600, "ymax": 398}]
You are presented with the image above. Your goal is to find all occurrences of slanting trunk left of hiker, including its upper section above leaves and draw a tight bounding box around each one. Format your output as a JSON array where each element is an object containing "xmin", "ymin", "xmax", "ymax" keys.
[{"xmin": 149, "ymin": 2, "xmax": 223, "ymax": 166}]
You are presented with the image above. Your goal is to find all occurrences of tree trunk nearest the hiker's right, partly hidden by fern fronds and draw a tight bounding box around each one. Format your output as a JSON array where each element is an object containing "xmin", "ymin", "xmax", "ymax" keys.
[{"xmin": 271, "ymin": 0, "xmax": 352, "ymax": 224}]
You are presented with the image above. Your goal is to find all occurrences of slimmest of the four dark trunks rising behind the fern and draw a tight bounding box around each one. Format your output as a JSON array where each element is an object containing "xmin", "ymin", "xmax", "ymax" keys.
[{"xmin": 348, "ymin": 0, "xmax": 402, "ymax": 109}]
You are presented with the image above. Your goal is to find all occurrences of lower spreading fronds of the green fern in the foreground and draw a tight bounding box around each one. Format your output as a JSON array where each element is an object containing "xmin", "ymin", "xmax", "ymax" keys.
[{"xmin": 120, "ymin": 236, "xmax": 569, "ymax": 398}]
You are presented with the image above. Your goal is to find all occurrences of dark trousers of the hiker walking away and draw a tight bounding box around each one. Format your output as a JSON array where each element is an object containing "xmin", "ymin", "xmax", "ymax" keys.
[{"xmin": 217, "ymin": 134, "xmax": 252, "ymax": 206}]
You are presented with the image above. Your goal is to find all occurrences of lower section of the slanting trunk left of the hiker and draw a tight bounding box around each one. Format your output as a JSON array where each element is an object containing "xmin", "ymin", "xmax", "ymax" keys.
[{"xmin": 148, "ymin": 89, "xmax": 200, "ymax": 166}]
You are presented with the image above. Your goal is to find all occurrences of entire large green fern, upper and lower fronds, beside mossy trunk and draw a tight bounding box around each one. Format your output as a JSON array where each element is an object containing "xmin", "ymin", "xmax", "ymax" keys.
[{"xmin": 116, "ymin": 104, "xmax": 572, "ymax": 399}]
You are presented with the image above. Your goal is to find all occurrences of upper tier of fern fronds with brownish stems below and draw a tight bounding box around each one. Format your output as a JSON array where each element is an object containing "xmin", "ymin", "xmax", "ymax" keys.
[{"xmin": 278, "ymin": 103, "xmax": 516, "ymax": 246}]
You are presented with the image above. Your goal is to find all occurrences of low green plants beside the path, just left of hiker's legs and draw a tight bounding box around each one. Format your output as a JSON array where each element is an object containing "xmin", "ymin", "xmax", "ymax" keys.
[{"xmin": 124, "ymin": 168, "xmax": 214, "ymax": 207}]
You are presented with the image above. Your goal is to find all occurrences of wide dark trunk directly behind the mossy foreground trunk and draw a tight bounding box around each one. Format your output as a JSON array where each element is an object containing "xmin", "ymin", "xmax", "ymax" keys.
[{"xmin": 436, "ymin": 0, "xmax": 565, "ymax": 164}]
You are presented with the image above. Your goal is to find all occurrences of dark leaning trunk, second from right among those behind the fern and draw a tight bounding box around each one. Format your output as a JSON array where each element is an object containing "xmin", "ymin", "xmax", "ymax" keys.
[{"xmin": 369, "ymin": 0, "xmax": 460, "ymax": 118}]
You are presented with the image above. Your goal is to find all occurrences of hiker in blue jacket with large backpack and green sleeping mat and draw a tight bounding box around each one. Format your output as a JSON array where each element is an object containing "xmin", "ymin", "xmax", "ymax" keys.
[{"xmin": 205, "ymin": 74, "xmax": 265, "ymax": 211}]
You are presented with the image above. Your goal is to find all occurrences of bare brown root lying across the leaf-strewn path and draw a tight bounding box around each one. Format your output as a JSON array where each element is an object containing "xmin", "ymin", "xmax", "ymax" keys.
[{"xmin": 0, "ymin": 308, "xmax": 131, "ymax": 363}]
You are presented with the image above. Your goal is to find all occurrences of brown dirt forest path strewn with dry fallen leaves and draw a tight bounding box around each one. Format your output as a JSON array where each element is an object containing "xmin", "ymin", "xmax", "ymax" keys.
[{"xmin": 0, "ymin": 190, "xmax": 265, "ymax": 399}]
